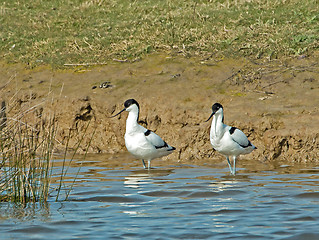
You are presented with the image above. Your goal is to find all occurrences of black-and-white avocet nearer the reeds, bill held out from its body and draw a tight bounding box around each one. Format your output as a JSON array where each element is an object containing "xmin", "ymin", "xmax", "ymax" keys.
[{"xmin": 112, "ymin": 99, "xmax": 175, "ymax": 169}]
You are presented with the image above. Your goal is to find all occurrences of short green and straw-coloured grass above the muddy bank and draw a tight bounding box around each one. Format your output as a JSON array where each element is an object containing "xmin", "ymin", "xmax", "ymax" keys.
[{"xmin": 0, "ymin": 0, "xmax": 319, "ymax": 67}]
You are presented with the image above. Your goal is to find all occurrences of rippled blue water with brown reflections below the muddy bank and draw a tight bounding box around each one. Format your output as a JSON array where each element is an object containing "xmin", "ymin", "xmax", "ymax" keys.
[{"xmin": 0, "ymin": 156, "xmax": 319, "ymax": 240}]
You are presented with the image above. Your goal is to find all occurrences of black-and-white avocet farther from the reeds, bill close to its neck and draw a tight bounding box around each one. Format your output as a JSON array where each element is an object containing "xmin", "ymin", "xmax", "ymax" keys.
[{"xmin": 206, "ymin": 103, "xmax": 257, "ymax": 175}]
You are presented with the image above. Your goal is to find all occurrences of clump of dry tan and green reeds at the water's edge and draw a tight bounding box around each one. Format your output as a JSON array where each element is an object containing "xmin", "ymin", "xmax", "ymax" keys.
[{"xmin": 0, "ymin": 98, "xmax": 93, "ymax": 204}]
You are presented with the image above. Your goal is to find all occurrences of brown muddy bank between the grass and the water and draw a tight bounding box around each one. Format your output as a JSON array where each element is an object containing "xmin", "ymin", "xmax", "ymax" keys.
[{"xmin": 0, "ymin": 55, "xmax": 319, "ymax": 167}]
